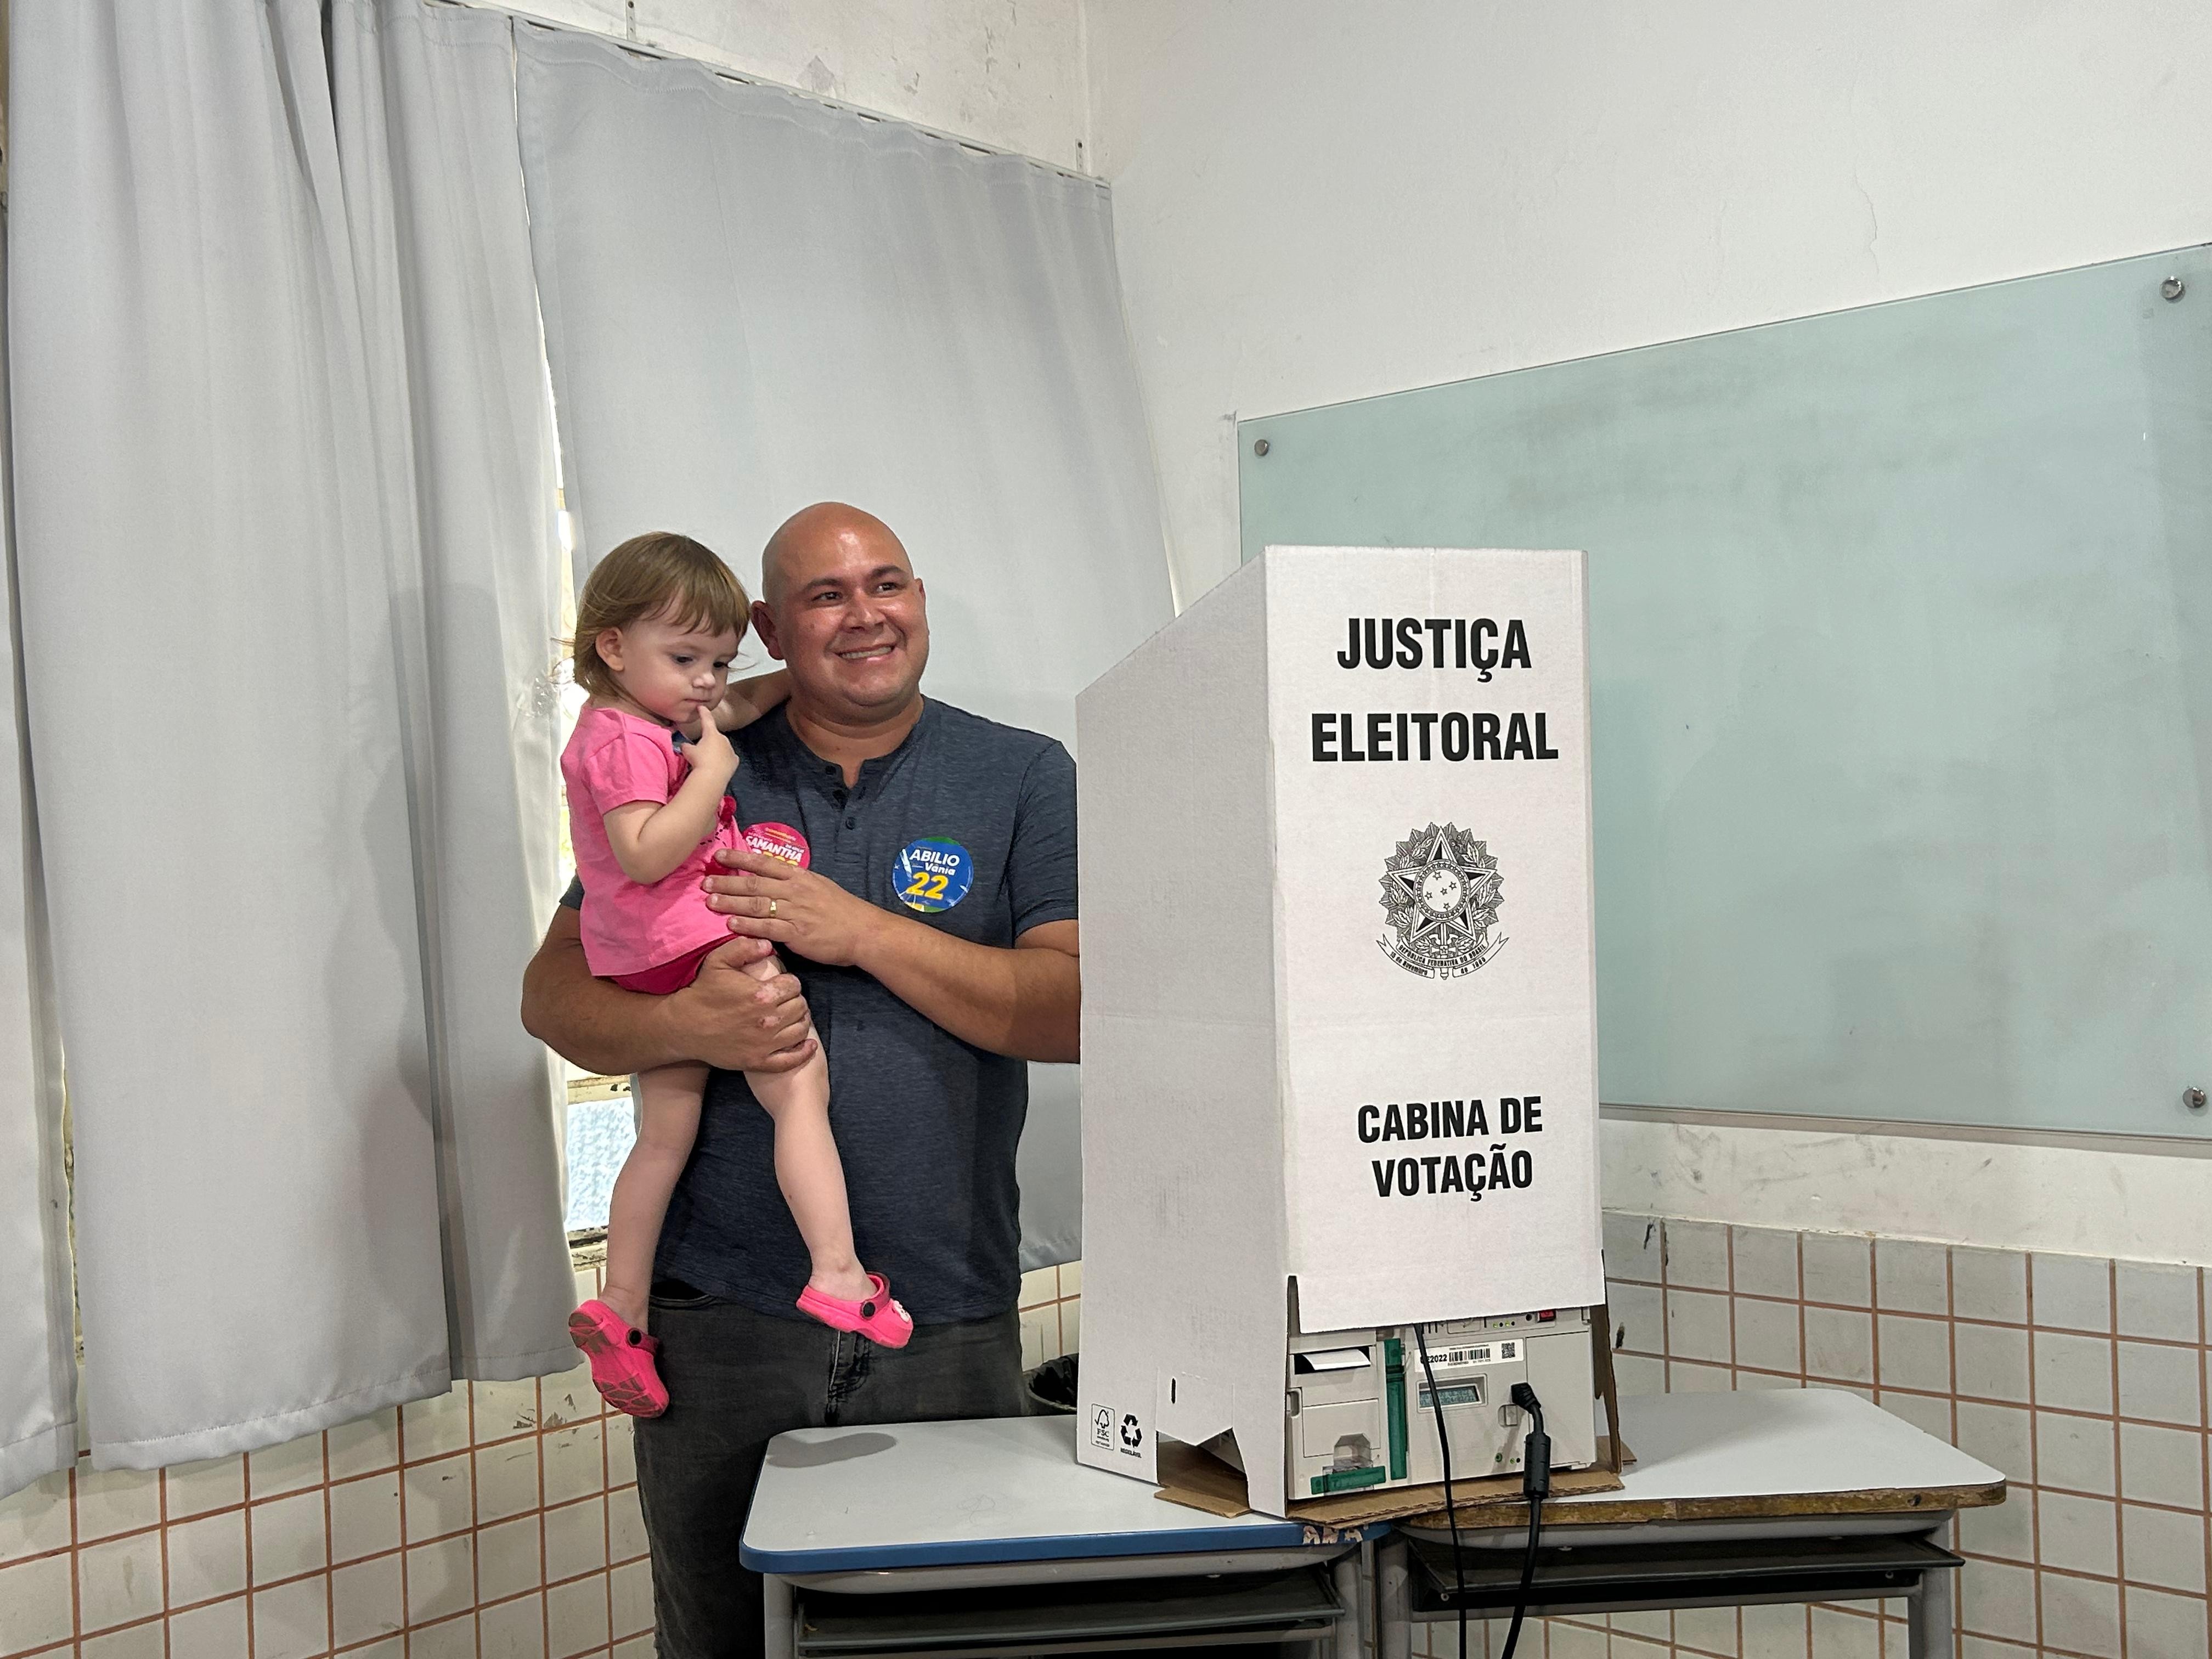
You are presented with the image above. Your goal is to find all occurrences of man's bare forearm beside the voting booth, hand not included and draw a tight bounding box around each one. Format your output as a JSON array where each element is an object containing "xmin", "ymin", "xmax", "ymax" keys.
[{"xmin": 854, "ymin": 911, "xmax": 1082, "ymax": 1059}]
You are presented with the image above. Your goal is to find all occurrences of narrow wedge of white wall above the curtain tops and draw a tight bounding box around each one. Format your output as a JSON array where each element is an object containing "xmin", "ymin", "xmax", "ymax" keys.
[{"xmin": 500, "ymin": 0, "xmax": 1086, "ymax": 170}]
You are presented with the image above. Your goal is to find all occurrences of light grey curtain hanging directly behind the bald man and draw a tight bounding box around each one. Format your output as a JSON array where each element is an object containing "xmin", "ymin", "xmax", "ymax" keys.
[{"xmin": 517, "ymin": 26, "xmax": 1172, "ymax": 1265}]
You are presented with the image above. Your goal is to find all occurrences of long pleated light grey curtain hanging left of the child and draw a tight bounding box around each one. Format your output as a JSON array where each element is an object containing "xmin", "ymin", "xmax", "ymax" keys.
[{"xmin": 0, "ymin": 0, "xmax": 571, "ymax": 1466}]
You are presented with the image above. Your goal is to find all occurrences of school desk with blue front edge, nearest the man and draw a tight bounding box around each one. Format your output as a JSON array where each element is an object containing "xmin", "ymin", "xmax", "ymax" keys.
[{"xmin": 741, "ymin": 1418, "xmax": 1387, "ymax": 1659}]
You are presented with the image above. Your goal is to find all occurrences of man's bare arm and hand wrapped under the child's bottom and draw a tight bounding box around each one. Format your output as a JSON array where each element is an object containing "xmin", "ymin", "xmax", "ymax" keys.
[{"xmin": 522, "ymin": 905, "xmax": 814, "ymax": 1075}]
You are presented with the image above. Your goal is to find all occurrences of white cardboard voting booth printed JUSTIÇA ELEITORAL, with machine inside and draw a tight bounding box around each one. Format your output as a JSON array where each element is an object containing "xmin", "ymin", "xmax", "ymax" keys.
[{"xmin": 1077, "ymin": 546, "xmax": 1604, "ymax": 1513}]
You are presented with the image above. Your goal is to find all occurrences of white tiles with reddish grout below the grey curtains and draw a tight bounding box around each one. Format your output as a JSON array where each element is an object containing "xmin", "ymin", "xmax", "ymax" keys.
[{"xmin": 0, "ymin": 1265, "xmax": 1080, "ymax": 1659}]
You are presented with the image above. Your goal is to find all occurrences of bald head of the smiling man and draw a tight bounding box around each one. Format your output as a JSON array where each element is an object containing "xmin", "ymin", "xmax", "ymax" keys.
[{"xmin": 752, "ymin": 502, "xmax": 929, "ymax": 725}]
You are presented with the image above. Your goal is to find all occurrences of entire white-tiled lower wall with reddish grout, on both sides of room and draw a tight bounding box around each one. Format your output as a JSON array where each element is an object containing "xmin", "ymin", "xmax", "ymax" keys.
[{"xmin": 13, "ymin": 1215, "xmax": 2212, "ymax": 1659}]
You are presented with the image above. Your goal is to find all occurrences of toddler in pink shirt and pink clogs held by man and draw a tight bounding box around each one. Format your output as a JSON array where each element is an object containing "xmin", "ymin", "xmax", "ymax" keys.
[{"xmin": 560, "ymin": 533, "xmax": 913, "ymax": 1418}]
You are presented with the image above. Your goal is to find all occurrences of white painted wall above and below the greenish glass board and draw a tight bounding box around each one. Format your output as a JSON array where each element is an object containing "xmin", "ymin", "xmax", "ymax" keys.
[{"xmin": 1086, "ymin": 0, "xmax": 2212, "ymax": 1263}]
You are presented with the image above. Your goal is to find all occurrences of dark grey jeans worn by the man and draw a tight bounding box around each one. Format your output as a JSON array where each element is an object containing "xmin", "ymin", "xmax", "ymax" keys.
[{"xmin": 637, "ymin": 1283, "xmax": 1029, "ymax": 1659}]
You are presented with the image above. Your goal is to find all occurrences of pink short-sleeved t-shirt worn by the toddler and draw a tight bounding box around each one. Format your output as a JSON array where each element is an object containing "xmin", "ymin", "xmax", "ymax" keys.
[{"xmin": 560, "ymin": 708, "xmax": 739, "ymax": 980}]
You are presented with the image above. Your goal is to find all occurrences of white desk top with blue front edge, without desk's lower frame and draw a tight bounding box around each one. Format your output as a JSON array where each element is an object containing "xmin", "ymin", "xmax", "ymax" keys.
[{"xmin": 739, "ymin": 1418, "xmax": 1358, "ymax": 1573}]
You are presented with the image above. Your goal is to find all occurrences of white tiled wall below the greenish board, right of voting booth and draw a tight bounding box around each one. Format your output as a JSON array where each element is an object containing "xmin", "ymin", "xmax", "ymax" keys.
[{"xmin": 1425, "ymin": 1215, "xmax": 2212, "ymax": 1659}]
